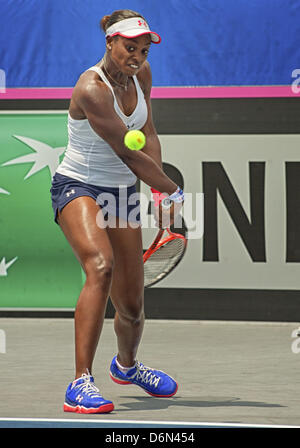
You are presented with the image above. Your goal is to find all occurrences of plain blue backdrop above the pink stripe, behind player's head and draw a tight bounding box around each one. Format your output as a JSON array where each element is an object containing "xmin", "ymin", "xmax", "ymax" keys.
[{"xmin": 0, "ymin": 0, "xmax": 300, "ymax": 87}]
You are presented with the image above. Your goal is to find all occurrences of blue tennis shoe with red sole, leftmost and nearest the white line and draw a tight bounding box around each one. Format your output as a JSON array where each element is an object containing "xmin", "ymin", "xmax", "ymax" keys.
[{"xmin": 64, "ymin": 373, "xmax": 114, "ymax": 414}]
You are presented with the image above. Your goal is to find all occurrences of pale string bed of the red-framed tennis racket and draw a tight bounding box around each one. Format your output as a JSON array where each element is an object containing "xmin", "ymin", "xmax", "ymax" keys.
[{"xmin": 144, "ymin": 238, "xmax": 185, "ymax": 287}]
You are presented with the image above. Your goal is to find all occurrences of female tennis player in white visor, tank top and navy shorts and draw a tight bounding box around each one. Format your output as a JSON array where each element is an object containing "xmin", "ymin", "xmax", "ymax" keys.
[{"xmin": 51, "ymin": 10, "xmax": 183, "ymax": 413}]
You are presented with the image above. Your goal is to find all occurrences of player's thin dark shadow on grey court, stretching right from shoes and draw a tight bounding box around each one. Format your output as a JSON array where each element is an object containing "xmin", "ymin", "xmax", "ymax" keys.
[{"xmin": 118, "ymin": 396, "xmax": 285, "ymax": 412}]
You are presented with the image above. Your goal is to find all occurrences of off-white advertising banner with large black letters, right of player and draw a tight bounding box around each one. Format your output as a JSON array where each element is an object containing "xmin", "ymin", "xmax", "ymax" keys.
[{"xmin": 149, "ymin": 134, "xmax": 300, "ymax": 290}]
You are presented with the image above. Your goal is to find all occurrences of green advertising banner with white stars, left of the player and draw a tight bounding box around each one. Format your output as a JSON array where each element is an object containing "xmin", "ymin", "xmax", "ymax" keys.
[{"xmin": 0, "ymin": 112, "xmax": 81, "ymax": 308}]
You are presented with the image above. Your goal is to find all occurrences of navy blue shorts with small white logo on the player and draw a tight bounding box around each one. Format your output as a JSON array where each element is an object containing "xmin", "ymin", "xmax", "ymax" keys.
[{"xmin": 50, "ymin": 173, "xmax": 140, "ymax": 224}]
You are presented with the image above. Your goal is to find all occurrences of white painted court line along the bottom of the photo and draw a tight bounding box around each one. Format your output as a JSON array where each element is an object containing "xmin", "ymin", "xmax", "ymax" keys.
[{"xmin": 0, "ymin": 417, "xmax": 300, "ymax": 428}]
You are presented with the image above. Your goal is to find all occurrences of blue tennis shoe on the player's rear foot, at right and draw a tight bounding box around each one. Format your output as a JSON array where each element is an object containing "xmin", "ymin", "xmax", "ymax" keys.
[{"xmin": 110, "ymin": 356, "xmax": 178, "ymax": 398}]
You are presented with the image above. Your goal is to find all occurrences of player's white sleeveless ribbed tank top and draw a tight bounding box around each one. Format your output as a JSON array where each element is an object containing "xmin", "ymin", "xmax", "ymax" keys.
[{"xmin": 56, "ymin": 67, "xmax": 148, "ymax": 187}]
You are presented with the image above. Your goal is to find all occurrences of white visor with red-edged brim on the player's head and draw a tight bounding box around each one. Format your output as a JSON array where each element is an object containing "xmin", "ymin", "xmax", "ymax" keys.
[{"xmin": 105, "ymin": 17, "xmax": 161, "ymax": 44}]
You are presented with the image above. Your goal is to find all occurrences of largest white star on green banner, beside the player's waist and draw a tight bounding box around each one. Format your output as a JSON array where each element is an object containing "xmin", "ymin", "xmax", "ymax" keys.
[{"xmin": 2, "ymin": 135, "xmax": 66, "ymax": 180}]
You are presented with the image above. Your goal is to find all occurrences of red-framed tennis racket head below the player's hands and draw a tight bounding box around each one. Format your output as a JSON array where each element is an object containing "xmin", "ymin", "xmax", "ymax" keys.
[{"xmin": 143, "ymin": 229, "xmax": 187, "ymax": 288}]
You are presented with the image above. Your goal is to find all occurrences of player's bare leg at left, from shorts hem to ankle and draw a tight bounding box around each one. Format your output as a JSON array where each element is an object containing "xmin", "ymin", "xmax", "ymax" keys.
[{"xmin": 59, "ymin": 197, "xmax": 113, "ymax": 378}]
